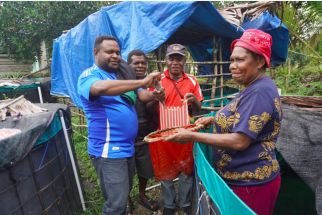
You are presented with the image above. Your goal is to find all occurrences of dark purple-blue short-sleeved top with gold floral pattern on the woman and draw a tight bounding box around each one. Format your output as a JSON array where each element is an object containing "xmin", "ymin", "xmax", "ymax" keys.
[{"xmin": 213, "ymin": 76, "xmax": 282, "ymax": 186}]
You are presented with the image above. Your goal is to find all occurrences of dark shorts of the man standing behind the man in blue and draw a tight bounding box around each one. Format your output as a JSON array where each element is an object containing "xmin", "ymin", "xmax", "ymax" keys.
[{"xmin": 135, "ymin": 144, "xmax": 154, "ymax": 179}]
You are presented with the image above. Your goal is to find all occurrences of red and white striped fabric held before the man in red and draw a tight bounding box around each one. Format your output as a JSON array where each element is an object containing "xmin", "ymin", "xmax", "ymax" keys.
[{"xmin": 159, "ymin": 102, "xmax": 190, "ymax": 130}]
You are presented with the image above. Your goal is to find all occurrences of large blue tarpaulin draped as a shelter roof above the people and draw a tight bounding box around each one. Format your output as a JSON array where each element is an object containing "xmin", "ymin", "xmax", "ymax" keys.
[{"xmin": 51, "ymin": 1, "xmax": 289, "ymax": 108}]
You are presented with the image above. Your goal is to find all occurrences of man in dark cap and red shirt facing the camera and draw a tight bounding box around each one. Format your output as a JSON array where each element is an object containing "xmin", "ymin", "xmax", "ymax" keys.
[{"xmin": 150, "ymin": 44, "xmax": 203, "ymax": 215}]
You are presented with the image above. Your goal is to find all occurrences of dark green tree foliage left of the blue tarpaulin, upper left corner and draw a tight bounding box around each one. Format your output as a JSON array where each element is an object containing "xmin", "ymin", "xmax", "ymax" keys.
[{"xmin": 0, "ymin": 1, "xmax": 117, "ymax": 60}]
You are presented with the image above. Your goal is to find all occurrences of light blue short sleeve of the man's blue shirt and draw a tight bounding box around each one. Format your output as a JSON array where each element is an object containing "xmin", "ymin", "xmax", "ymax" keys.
[{"xmin": 77, "ymin": 71, "xmax": 101, "ymax": 101}]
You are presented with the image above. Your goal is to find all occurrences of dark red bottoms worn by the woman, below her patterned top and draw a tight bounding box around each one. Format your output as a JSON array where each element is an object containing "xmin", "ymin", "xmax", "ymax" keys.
[{"xmin": 229, "ymin": 175, "xmax": 281, "ymax": 215}]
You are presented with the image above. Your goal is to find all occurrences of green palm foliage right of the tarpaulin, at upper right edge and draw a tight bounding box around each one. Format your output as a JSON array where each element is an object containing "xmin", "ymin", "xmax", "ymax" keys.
[{"xmin": 275, "ymin": 2, "xmax": 322, "ymax": 96}]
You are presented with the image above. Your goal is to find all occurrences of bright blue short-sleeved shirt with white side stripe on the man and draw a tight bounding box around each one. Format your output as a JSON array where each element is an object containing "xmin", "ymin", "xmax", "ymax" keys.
[{"xmin": 77, "ymin": 65, "xmax": 138, "ymax": 158}]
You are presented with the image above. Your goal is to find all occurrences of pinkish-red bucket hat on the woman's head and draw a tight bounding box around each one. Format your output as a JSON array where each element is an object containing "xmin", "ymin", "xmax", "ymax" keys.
[{"xmin": 230, "ymin": 29, "xmax": 272, "ymax": 67}]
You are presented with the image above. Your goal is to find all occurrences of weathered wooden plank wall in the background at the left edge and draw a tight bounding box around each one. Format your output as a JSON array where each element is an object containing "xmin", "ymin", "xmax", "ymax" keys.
[{"xmin": 0, "ymin": 54, "xmax": 32, "ymax": 72}]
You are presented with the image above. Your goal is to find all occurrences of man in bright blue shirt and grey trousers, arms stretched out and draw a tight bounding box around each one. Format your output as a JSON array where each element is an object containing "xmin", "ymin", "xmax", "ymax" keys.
[{"xmin": 77, "ymin": 36, "xmax": 164, "ymax": 214}]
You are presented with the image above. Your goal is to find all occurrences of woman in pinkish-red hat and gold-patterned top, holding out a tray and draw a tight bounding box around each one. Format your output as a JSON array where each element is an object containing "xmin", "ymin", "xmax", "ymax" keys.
[{"xmin": 167, "ymin": 29, "xmax": 282, "ymax": 215}]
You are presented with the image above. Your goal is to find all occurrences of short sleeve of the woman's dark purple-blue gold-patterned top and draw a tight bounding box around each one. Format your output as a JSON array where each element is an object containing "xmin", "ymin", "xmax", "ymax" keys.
[{"xmin": 232, "ymin": 91, "xmax": 274, "ymax": 139}]
